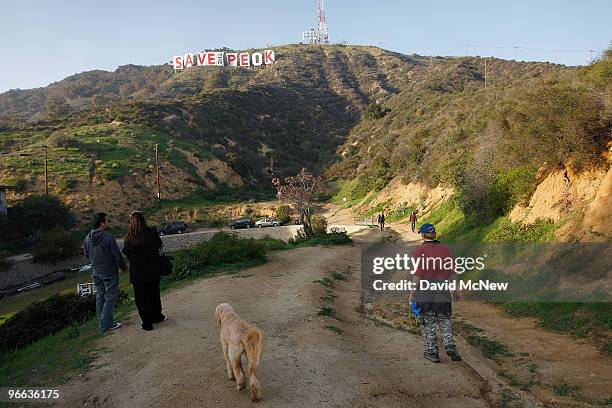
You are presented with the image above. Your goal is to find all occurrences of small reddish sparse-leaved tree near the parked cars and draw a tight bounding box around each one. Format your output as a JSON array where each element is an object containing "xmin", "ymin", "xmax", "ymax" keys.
[{"xmin": 272, "ymin": 168, "xmax": 323, "ymax": 238}]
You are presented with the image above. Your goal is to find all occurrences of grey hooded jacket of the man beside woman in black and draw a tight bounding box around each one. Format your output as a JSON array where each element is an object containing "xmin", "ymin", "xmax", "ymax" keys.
[{"xmin": 83, "ymin": 229, "xmax": 125, "ymax": 276}]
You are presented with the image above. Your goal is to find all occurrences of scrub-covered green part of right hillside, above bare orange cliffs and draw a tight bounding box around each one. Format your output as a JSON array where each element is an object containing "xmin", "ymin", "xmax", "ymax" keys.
[{"xmin": 327, "ymin": 48, "xmax": 612, "ymax": 230}]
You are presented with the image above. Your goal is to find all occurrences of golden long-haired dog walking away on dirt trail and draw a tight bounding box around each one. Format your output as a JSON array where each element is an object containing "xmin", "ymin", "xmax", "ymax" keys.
[{"xmin": 215, "ymin": 303, "xmax": 263, "ymax": 402}]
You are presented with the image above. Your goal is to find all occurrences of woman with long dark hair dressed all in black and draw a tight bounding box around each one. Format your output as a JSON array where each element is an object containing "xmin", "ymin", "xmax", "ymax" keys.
[{"xmin": 122, "ymin": 211, "xmax": 166, "ymax": 331}]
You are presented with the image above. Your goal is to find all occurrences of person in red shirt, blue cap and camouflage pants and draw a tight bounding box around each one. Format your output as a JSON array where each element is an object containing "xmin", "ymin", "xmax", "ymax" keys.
[{"xmin": 410, "ymin": 224, "xmax": 461, "ymax": 363}]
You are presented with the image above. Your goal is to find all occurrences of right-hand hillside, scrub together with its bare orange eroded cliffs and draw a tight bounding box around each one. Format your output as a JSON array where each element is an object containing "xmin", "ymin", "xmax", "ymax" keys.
[{"xmin": 327, "ymin": 52, "xmax": 612, "ymax": 241}]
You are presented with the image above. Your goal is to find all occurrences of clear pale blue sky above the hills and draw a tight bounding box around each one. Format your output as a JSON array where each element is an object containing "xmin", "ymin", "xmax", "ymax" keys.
[{"xmin": 0, "ymin": 0, "xmax": 612, "ymax": 92}]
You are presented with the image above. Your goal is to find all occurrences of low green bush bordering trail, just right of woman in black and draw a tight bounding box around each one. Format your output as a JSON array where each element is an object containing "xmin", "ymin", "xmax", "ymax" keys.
[{"xmin": 170, "ymin": 232, "xmax": 266, "ymax": 280}]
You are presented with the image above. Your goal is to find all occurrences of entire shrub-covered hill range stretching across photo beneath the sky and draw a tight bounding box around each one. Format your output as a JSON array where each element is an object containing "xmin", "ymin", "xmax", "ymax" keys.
[{"xmin": 0, "ymin": 45, "xmax": 610, "ymax": 231}]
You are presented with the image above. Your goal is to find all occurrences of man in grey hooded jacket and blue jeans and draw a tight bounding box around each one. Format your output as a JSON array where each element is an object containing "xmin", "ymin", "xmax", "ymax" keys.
[{"xmin": 83, "ymin": 213, "xmax": 127, "ymax": 334}]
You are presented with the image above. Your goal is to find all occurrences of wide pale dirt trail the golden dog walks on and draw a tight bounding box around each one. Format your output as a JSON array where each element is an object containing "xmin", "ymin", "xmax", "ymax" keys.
[{"xmin": 62, "ymin": 231, "xmax": 490, "ymax": 408}]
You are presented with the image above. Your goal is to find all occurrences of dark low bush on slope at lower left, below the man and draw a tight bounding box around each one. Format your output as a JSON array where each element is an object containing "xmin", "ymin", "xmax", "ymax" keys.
[{"xmin": 0, "ymin": 294, "xmax": 96, "ymax": 353}]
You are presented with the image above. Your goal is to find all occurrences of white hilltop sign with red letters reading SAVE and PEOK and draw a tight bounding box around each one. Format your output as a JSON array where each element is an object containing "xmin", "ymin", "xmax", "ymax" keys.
[{"xmin": 172, "ymin": 50, "xmax": 276, "ymax": 71}]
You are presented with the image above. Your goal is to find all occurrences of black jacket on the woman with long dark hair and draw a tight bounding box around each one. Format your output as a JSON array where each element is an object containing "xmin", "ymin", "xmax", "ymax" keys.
[{"xmin": 123, "ymin": 228, "xmax": 163, "ymax": 283}]
